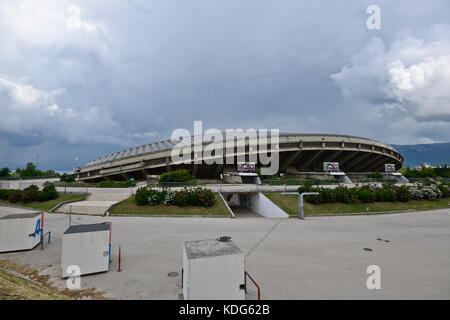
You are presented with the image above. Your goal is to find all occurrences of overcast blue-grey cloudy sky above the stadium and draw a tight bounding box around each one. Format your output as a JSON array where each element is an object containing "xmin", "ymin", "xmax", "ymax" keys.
[{"xmin": 0, "ymin": 0, "xmax": 450, "ymax": 170}]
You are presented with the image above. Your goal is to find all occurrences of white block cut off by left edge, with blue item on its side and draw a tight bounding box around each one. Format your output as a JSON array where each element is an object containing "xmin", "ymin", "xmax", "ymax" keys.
[{"xmin": 0, "ymin": 212, "xmax": 43, "ymax": 252}]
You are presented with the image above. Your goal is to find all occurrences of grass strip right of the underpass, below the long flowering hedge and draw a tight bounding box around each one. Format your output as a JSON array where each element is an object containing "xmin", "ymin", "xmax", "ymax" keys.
[{"xmin": 265, "ymin": 193, "xmax": 450, "ymax": 216}]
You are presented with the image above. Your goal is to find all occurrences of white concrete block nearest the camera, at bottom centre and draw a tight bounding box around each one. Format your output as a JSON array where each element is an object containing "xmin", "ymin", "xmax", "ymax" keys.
[{"xmin": 183, "ymin": 240, "xmax": 245, "ymax": 300}]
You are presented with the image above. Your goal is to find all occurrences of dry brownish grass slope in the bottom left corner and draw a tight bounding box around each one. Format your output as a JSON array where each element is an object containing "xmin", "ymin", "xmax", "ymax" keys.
[{"xmin": 0, "ymin": 260, "xmax": 107, "ymax": 300}]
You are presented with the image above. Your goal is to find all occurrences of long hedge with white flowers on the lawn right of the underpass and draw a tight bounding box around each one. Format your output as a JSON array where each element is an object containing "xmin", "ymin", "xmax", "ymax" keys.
[{"xmin": 298, "ymin": 183, "xmax": 450, "ymax": 204}]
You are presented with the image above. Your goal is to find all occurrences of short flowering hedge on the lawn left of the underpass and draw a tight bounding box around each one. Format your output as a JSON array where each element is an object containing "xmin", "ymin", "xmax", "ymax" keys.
[{"xmin": 135, "ymin": 187, "xmax": 216, "ymax": 207}]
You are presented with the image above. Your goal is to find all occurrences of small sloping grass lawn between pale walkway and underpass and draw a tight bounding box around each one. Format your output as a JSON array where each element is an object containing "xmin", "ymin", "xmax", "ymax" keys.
[{"xmin": 109, "ymin": 194, "xmax": 230, "ymax": 216}]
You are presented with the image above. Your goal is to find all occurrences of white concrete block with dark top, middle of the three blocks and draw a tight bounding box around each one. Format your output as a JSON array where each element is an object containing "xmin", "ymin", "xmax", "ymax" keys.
[{"xmin": 61, "ymin": 222, "xmax": 111, "ymax": 278}]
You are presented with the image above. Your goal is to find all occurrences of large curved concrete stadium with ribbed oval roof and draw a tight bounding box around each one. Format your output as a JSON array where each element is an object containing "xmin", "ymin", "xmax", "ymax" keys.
[{"xmin": 74, "ymin": 133, "xmax": 403, "ymax": 181}]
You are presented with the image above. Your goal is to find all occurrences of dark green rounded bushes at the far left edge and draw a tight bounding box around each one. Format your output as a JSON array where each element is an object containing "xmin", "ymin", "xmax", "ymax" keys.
[{"xmin": 0, "ymin": 184, "xmax": 59, "ymax": 203}]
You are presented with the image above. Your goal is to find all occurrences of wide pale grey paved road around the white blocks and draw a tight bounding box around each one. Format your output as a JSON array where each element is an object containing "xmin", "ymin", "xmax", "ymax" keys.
[{"xmin": 0, "ymin": 207, "xmax": 450, "ymax": 299}]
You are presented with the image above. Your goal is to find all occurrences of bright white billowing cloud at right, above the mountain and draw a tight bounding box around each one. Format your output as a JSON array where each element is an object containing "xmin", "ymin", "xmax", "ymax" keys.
[{"xmin": 331, "ymin": 25, "xmax": 450, "ymax": 141}]
